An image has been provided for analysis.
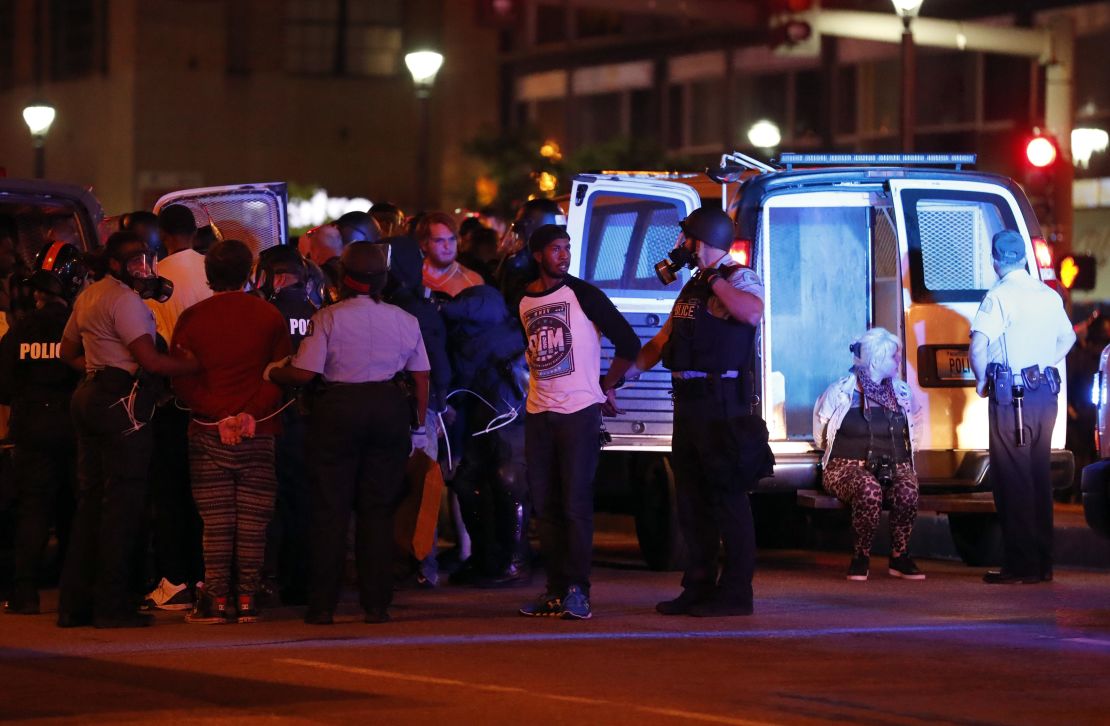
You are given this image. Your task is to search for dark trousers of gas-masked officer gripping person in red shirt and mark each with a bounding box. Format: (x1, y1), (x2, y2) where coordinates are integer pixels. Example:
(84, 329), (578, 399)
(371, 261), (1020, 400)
(58, 369), (151, 618)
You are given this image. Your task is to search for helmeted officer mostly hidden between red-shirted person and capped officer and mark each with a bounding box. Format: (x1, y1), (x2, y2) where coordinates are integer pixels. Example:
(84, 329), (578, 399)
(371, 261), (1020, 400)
(251, 244), (316, 605)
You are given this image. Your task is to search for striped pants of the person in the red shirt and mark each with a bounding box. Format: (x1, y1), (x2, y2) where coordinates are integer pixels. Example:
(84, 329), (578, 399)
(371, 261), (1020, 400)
(189, 428), (278, 597)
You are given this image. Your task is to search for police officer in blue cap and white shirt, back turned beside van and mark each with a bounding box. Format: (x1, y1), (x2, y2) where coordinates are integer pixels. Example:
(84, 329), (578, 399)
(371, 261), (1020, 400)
(970, 230), (1076, 585)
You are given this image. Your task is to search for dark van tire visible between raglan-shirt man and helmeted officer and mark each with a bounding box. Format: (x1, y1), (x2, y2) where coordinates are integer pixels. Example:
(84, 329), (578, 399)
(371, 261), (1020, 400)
(635, 456), (686, 571)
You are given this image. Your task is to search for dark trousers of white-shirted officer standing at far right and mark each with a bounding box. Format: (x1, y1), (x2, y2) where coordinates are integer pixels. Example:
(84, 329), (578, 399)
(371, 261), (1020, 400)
(988, 384), (1057, 576)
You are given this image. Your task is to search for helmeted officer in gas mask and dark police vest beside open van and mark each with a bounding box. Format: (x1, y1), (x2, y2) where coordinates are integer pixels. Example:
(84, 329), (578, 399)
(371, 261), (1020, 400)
(637, 208), (774, 616)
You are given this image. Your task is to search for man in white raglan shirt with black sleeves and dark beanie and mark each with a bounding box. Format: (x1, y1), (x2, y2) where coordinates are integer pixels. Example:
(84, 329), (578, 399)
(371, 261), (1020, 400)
(519, 224), (639, 619)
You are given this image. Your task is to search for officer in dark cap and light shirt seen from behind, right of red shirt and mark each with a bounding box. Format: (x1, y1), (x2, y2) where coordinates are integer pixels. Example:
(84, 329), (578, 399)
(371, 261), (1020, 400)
(266, 242), (430, 625)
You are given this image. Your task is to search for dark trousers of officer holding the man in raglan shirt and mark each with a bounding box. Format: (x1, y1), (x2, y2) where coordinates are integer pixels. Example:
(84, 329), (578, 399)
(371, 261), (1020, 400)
(670, 380), (765, 604)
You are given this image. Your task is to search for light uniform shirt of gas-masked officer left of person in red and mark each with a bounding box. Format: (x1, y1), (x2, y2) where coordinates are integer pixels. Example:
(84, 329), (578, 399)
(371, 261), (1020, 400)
(62, 275), (155, 375)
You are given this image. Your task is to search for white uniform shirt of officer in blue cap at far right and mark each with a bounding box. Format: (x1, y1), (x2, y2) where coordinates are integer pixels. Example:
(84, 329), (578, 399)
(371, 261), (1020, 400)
(971, 270), (1072, 374)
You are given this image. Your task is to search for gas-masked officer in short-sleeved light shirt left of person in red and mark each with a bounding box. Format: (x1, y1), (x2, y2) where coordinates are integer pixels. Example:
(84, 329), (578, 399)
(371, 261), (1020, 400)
(58, 232), (198, 627)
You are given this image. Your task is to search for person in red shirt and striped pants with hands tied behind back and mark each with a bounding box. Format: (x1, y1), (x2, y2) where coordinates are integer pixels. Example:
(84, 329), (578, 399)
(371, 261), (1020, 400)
(172, 240), (291, 624)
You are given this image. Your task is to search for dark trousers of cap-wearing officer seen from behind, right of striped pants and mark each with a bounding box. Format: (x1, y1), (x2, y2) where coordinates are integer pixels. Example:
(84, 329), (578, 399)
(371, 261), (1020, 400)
(309, 383), (411, 612)
